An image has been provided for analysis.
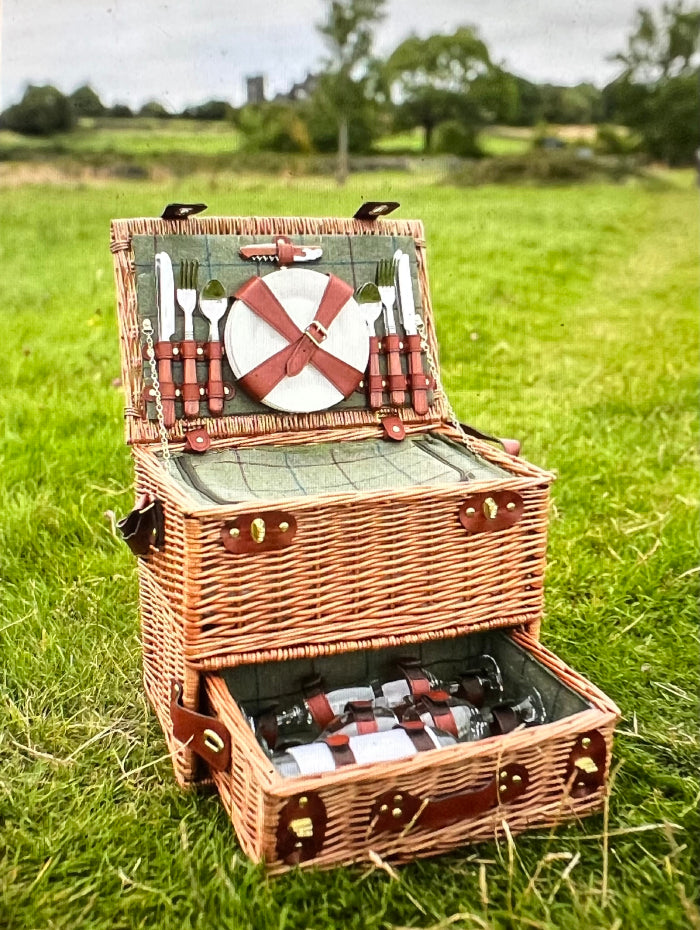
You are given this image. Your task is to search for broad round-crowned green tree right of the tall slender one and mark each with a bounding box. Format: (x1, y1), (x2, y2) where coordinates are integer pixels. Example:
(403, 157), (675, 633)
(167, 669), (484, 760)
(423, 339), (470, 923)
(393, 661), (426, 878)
(386, 26), (517, 151)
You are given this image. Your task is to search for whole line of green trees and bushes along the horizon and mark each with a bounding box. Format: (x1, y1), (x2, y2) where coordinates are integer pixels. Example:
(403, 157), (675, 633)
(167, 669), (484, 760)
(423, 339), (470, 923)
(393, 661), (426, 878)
(0, 0), (700, 167)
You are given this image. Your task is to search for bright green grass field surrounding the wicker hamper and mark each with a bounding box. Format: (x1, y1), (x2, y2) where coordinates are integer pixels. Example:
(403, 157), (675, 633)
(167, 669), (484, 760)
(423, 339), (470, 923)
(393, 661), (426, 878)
(0, 174), (700, 930)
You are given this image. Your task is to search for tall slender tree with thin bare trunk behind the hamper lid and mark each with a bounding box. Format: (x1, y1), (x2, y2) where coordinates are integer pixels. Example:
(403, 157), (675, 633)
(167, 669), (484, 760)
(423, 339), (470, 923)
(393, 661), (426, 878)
(317, 0), (386, 184)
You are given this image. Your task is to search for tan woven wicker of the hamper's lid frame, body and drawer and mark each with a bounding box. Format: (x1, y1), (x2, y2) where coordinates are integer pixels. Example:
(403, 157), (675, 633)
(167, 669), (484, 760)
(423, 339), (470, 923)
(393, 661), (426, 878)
(111, 210), (619, 871)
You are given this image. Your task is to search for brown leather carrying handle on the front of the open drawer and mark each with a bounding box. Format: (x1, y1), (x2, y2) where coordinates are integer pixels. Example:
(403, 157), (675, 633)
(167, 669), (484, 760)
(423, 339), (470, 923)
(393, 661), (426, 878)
(370, 764), (530, 833)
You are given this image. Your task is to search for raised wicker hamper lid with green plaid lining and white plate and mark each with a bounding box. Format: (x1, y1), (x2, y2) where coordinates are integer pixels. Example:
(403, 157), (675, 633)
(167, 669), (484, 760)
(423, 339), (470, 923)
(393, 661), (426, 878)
(111, 217), (447, 444)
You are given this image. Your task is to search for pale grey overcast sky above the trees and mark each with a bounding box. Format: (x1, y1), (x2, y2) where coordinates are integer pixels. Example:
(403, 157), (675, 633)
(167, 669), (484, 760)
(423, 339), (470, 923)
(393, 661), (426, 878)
(0, 0), (662, 110)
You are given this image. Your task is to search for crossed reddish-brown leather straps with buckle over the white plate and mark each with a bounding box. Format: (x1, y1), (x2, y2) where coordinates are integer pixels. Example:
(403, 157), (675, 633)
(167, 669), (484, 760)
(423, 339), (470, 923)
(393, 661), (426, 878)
(235, 275), (362, 399)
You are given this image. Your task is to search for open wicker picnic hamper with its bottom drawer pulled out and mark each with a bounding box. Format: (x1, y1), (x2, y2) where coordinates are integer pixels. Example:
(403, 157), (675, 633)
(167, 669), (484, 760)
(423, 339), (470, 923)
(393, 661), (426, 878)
(111, 201), (618, 871)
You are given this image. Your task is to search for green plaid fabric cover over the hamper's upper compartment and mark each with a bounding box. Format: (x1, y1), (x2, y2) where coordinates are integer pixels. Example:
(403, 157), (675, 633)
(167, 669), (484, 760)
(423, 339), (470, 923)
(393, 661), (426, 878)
(170, 434), (506, 504)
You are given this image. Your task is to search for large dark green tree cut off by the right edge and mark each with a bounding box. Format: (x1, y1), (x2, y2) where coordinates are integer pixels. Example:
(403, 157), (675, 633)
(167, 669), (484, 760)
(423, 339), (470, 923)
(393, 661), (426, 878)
(604, 0), (700, 165)
